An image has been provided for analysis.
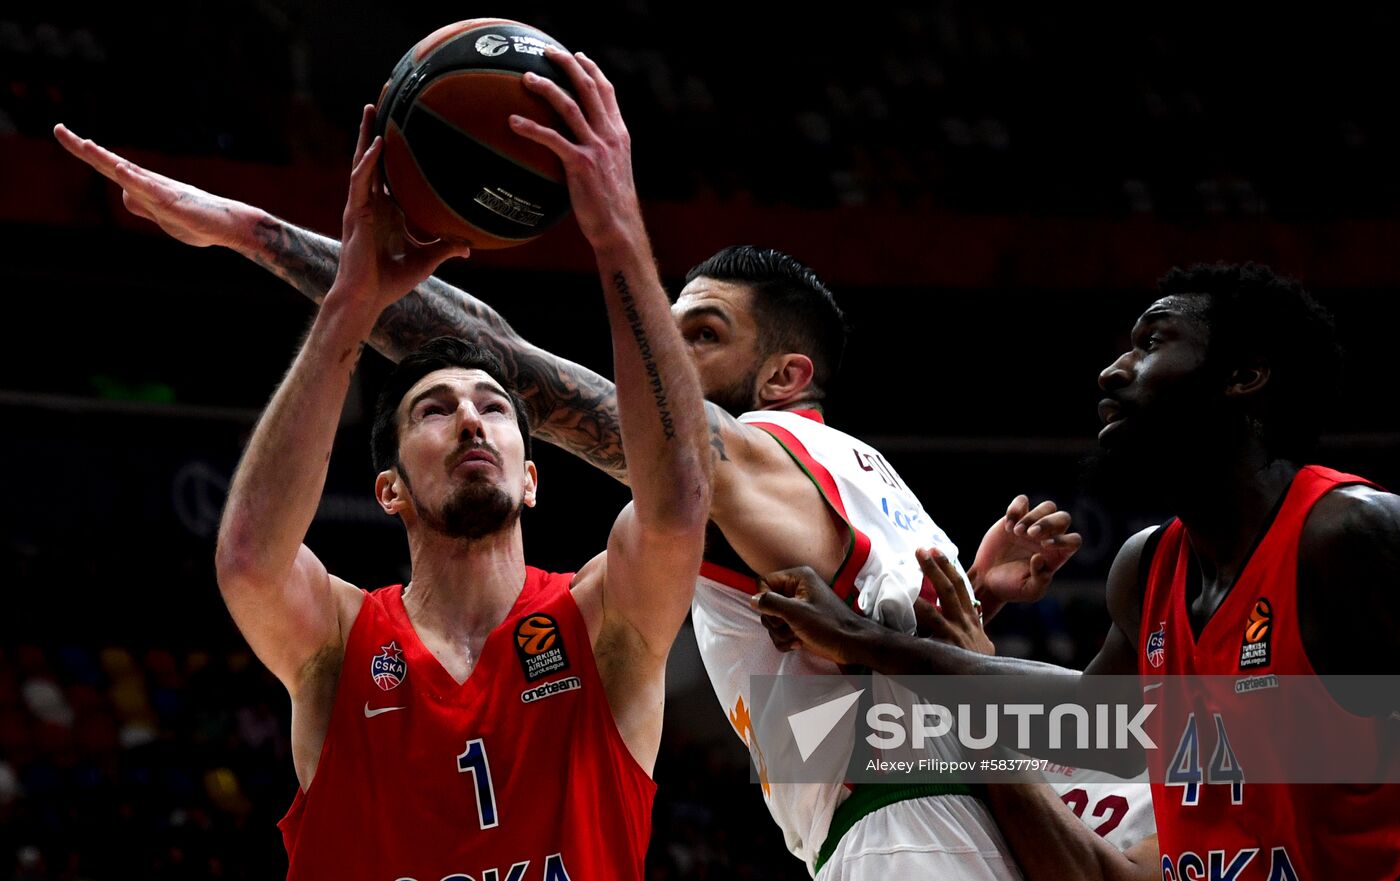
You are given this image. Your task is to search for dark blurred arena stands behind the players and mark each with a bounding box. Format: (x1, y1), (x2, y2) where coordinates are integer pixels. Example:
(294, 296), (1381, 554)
(0, 0), (1400, 881)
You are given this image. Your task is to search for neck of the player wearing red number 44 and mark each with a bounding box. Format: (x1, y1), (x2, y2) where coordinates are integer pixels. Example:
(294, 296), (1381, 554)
(1177, 451), (1298, 578)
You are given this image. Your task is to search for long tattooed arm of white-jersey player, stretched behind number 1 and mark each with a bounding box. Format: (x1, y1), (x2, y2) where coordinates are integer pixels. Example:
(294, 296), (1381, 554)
(55, 126), (789, 515)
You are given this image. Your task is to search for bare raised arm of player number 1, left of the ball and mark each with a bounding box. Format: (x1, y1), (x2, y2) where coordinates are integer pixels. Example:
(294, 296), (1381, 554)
(210, 108), (465, 686)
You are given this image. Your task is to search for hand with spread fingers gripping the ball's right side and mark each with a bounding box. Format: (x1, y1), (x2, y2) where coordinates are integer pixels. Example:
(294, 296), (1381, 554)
(510, 46), (643, 249)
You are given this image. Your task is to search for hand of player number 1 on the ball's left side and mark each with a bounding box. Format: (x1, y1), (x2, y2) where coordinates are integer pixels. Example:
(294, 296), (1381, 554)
(328, 105), (470, 314)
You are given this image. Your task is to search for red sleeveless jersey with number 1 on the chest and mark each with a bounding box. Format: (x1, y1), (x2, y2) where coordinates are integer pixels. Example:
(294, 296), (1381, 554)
(279, 567), (655, 881)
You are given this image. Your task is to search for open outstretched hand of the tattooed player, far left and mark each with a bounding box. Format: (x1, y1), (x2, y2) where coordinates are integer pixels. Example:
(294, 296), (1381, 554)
(53, 123), (252, 248)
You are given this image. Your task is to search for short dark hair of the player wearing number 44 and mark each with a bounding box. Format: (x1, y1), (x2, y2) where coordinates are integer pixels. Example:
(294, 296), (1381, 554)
(1158, 263), (1343, 458)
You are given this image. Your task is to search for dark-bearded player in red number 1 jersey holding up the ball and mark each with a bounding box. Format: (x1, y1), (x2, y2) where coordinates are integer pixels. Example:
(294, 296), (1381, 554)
(217, 52), (710, 881)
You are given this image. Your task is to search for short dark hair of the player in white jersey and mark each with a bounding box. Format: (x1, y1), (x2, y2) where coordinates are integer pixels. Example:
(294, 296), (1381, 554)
(686, 245), (847, 395)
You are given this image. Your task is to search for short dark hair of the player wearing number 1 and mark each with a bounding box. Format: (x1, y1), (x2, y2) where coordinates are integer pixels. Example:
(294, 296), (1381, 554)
(370, 336), (531, 471)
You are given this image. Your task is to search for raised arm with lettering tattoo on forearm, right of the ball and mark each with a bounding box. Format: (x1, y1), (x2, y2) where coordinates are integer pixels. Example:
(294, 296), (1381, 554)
(510, 49), (711, 769)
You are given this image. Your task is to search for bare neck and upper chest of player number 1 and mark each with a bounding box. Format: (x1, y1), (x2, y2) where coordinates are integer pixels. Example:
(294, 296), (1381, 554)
(403, 521), (525, 640)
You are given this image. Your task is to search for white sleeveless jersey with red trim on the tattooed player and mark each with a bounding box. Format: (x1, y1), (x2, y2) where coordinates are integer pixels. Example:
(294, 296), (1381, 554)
(692, 410), (1000, 870)
